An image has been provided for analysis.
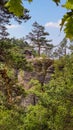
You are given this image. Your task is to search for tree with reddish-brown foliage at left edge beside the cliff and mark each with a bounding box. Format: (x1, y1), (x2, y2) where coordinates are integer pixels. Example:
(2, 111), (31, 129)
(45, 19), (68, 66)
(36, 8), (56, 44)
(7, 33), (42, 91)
(0, 64), (26, 107)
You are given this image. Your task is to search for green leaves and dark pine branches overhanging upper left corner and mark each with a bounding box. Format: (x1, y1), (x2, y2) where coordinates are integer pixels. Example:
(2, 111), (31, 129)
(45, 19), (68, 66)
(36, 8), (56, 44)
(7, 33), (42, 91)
(0, 0), (30, 39)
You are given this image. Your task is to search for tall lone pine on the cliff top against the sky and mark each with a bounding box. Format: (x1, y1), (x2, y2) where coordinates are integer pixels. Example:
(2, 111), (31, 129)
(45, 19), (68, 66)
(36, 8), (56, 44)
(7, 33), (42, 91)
(26, 22), (53, 56)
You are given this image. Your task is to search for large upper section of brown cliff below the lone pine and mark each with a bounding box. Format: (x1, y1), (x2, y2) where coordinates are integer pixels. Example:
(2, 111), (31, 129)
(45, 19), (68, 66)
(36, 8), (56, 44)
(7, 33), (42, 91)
(24, 59), (54, 85)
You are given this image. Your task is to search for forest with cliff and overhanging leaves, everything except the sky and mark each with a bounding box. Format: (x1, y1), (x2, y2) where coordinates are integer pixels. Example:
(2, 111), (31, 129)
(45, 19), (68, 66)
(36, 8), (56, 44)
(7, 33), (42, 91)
(0, 0), (73, 130)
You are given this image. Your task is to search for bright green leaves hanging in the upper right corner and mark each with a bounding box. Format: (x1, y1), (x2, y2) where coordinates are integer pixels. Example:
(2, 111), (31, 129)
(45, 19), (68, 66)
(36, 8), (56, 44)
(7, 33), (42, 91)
(53, 0), (73, 39)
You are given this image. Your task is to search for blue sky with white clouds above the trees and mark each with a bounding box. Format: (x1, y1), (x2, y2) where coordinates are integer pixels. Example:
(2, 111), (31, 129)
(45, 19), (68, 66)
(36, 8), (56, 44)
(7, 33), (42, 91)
(7, 0), (66, 45)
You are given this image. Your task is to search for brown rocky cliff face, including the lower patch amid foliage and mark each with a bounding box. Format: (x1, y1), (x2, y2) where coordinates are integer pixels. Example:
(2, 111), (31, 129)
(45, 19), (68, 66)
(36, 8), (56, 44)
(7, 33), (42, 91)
(18, 59), (54, 107)
